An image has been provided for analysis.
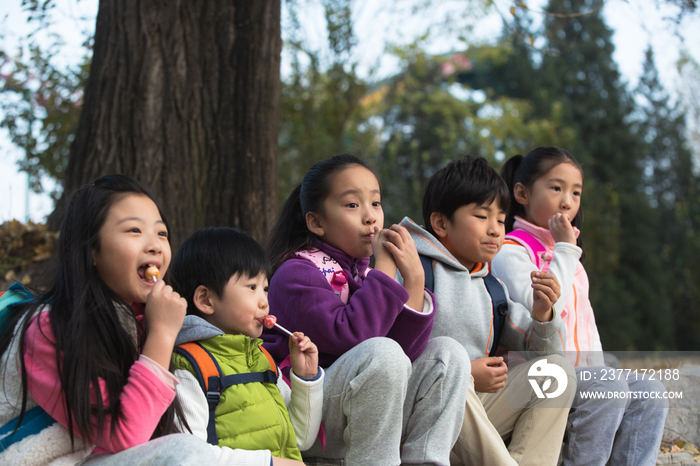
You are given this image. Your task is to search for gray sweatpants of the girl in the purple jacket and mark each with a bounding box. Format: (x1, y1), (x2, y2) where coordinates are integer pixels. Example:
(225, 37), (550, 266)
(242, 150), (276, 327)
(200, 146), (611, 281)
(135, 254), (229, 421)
(302, 337), (471, 466)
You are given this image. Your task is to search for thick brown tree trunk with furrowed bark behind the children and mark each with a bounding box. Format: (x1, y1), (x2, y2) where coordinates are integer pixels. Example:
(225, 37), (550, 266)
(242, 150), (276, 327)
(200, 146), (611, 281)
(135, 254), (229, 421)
(50, 0), (282, 248)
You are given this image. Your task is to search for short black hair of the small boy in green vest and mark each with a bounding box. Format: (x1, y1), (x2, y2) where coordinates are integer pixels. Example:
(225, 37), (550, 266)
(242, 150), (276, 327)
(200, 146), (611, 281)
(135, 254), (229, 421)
(169, 227), (270, 317)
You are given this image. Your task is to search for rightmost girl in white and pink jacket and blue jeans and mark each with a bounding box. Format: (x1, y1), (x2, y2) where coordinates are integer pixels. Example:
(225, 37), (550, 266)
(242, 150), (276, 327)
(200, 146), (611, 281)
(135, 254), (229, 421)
(491, 147), (668, 466)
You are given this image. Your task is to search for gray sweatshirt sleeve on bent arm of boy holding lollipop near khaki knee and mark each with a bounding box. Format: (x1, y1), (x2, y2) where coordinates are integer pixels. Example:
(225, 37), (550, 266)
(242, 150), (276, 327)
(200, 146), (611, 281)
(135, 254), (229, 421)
(499, 280), (566, 359)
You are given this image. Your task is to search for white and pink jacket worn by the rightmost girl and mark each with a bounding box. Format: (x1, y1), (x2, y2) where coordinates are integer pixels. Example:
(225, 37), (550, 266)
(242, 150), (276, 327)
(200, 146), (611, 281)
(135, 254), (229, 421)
(491, 217), (603, 366)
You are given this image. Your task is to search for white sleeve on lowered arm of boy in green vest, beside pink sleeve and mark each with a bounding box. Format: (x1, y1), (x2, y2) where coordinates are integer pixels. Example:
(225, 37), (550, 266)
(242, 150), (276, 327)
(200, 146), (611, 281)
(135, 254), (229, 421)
(175, 369), (272, 466)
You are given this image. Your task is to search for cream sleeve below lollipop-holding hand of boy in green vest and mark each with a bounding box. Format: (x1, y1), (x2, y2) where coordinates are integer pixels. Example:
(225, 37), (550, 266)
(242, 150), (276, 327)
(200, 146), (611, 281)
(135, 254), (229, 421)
(277, 367), (325, 451)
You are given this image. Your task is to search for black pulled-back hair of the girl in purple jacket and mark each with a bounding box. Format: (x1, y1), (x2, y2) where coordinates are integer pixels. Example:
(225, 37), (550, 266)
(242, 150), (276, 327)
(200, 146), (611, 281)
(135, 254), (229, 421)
(267, 154), (376, 273)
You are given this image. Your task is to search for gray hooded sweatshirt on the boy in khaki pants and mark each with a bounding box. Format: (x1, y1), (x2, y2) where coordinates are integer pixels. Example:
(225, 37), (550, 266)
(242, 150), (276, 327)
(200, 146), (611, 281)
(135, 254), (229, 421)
(397, 217), (566, 361)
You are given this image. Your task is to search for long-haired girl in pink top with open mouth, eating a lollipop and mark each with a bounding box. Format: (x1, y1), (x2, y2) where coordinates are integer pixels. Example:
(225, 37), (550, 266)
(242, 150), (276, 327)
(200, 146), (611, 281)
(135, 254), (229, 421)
(0, 175), (215, 465)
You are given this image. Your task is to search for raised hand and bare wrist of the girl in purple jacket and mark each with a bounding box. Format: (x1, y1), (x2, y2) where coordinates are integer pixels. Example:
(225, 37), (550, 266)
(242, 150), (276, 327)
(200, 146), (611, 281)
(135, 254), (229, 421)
(384, 224), (425, 311)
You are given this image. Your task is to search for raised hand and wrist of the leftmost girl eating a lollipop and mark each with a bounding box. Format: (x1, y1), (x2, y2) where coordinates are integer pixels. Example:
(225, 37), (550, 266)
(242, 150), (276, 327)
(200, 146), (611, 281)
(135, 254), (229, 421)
(142, 280), (187, 369)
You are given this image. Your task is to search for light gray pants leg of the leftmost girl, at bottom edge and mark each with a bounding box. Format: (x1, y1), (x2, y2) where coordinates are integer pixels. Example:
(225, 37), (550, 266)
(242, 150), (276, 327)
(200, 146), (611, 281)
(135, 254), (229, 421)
(79, 434), (217, 466)
